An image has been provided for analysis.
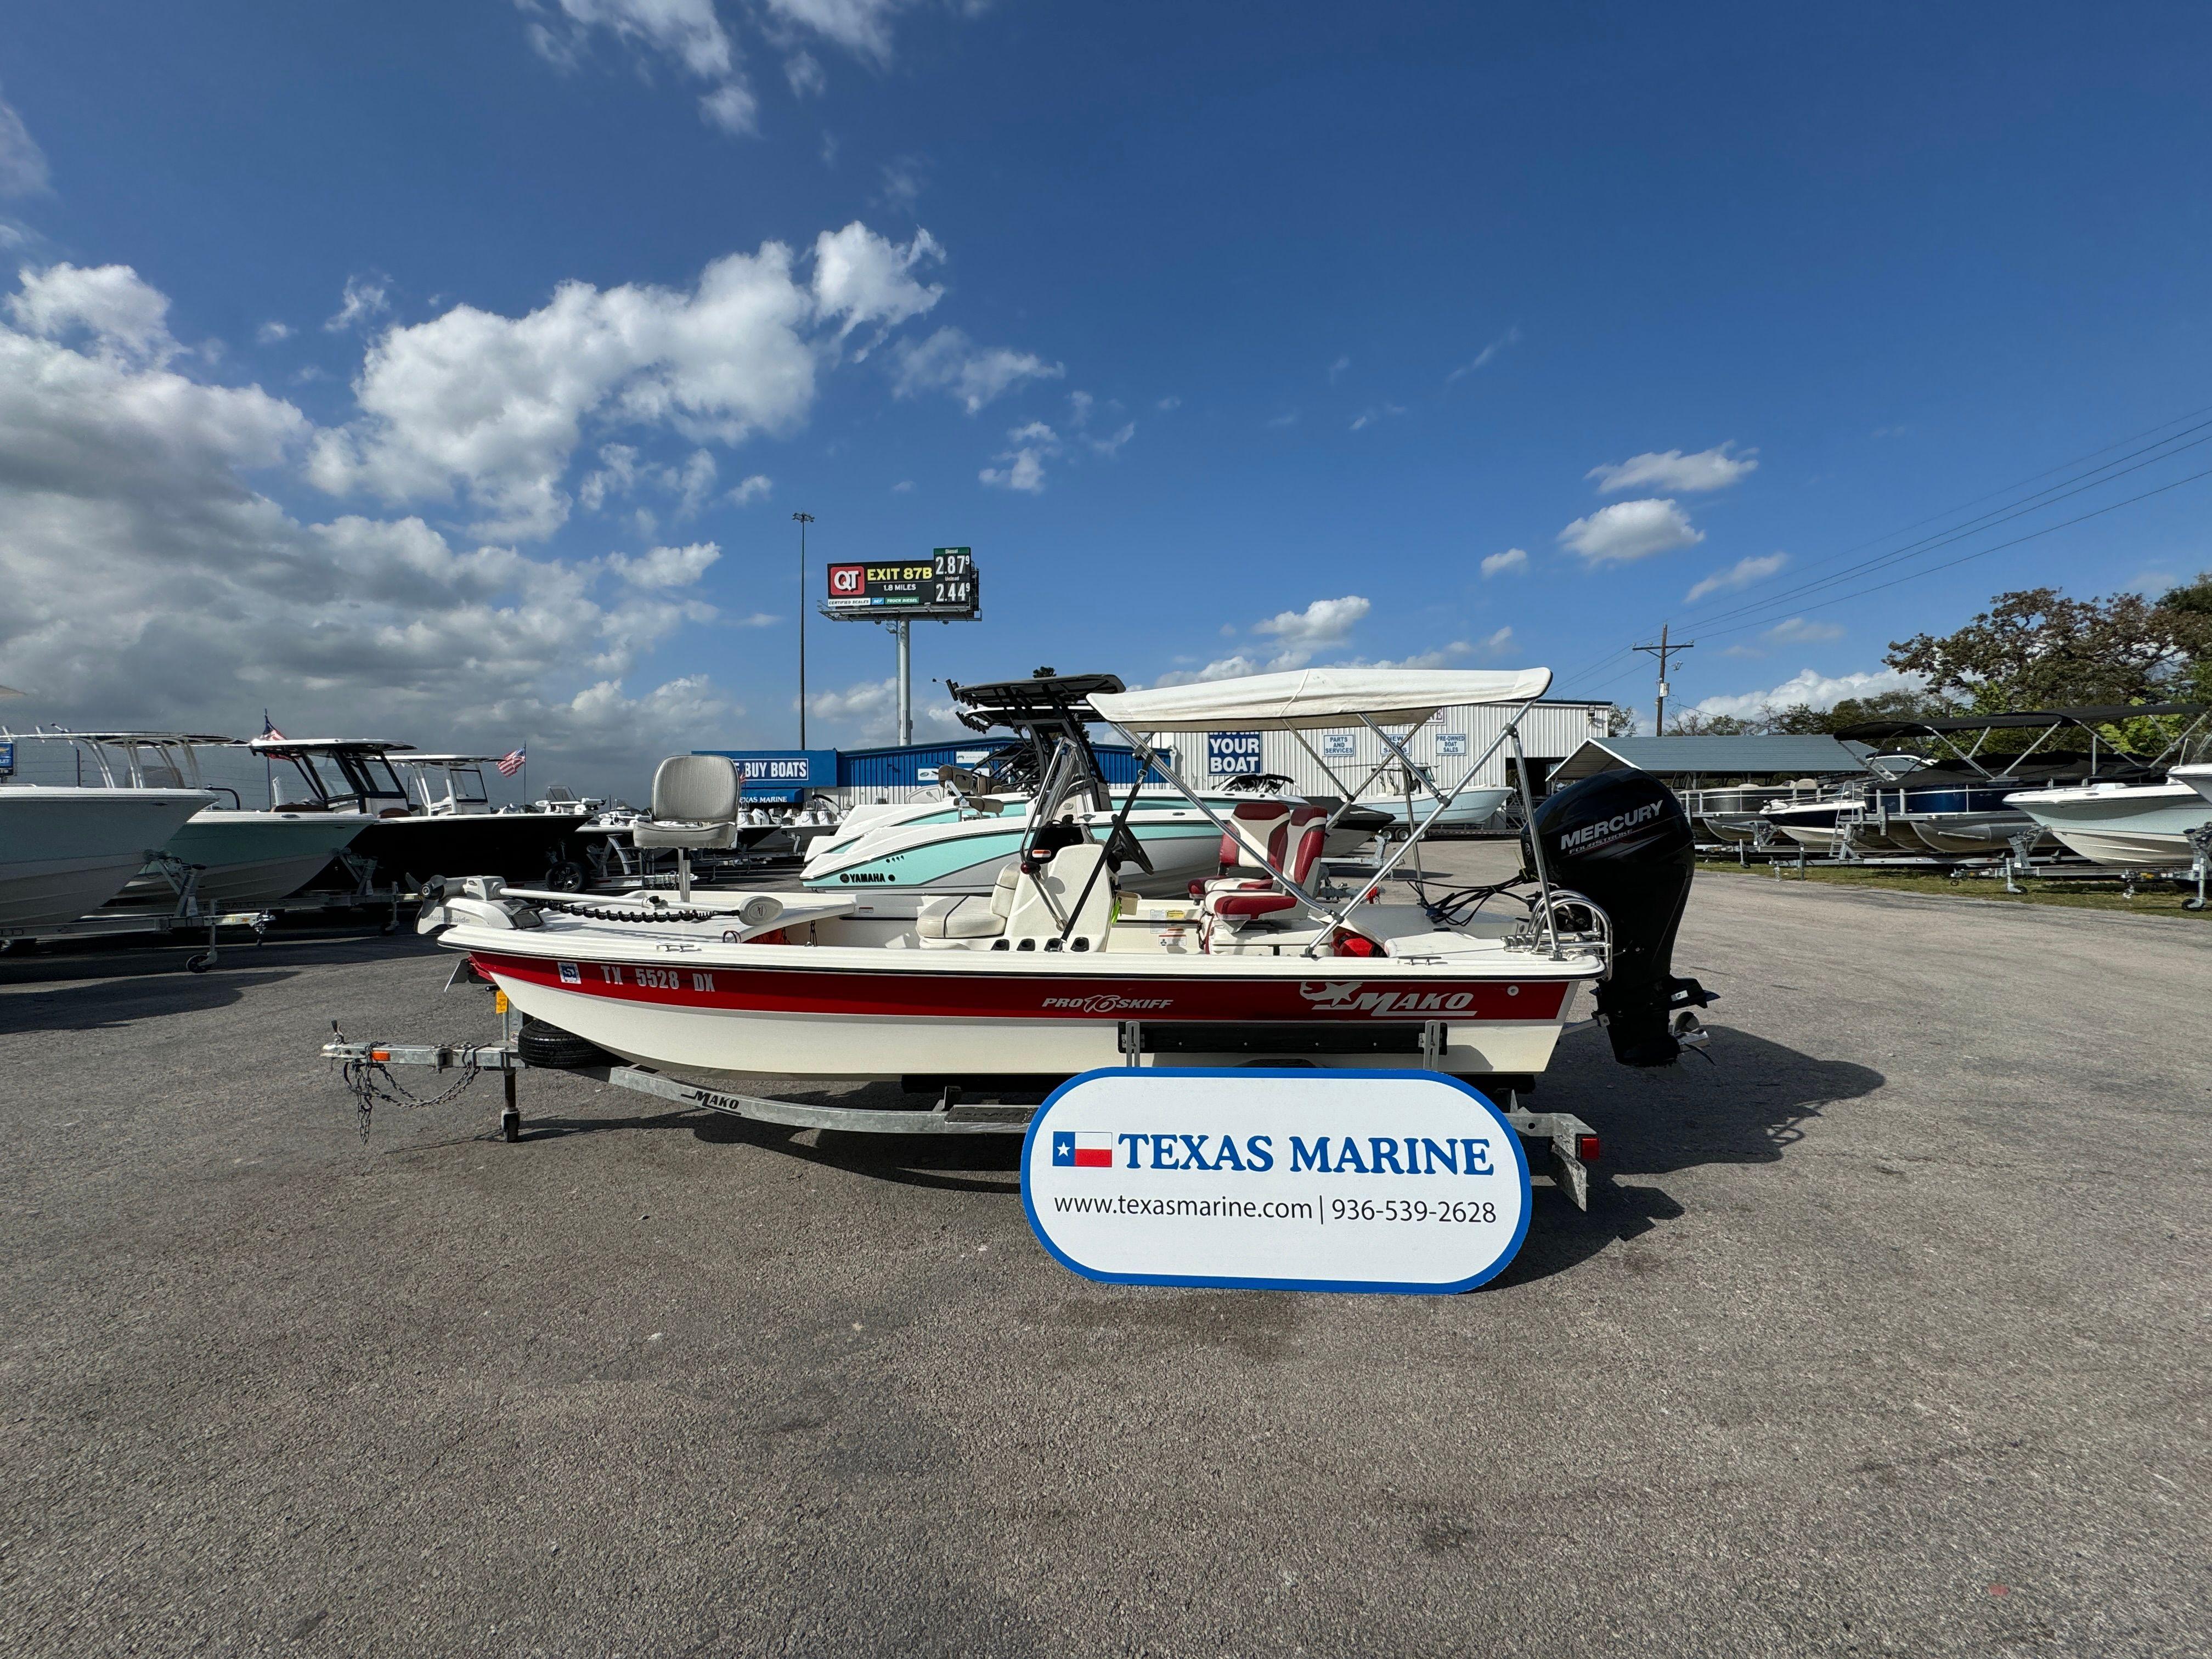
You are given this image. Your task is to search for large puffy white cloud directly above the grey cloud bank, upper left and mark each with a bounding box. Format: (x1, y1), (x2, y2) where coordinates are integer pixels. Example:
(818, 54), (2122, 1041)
(309, 241), (827, 538)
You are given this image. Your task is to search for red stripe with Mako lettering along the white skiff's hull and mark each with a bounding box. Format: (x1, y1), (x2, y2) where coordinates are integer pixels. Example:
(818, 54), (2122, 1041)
(471, 951), (1568, 1022)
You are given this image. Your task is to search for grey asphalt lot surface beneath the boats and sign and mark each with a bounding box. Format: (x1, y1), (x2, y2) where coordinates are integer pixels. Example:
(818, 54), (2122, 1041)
(0, 845), (2212, 1659)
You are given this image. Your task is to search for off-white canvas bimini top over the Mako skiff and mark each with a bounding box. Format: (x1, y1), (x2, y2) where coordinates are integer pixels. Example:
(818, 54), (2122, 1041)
(1091, 668), (1550, 732)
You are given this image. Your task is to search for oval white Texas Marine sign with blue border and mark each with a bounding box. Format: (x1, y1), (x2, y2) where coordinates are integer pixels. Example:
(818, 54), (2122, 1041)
(1022, 1068), (1528, 1294)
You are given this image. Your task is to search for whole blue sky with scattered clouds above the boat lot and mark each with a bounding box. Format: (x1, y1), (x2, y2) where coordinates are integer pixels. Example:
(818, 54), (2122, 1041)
(0, 0), (2212, 789)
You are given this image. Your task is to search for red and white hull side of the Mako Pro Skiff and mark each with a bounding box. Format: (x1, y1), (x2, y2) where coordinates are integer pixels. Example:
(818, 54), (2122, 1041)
(467, 940), (1575, 1080)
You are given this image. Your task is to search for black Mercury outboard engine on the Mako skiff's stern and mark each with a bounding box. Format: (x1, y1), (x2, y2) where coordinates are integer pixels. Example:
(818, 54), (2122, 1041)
(1522, 772), (1712, 1066)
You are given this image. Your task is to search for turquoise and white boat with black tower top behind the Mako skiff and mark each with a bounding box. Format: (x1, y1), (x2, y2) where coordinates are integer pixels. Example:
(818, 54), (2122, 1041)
(801, 673), (1398, 898)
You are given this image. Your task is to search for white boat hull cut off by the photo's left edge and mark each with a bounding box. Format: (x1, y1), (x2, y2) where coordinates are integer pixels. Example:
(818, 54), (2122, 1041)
(0, 783), (215, 934)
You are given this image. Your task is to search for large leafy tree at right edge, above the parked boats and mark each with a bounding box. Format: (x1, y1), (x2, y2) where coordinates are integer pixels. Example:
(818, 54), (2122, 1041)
(1887, 577), (2212, 714)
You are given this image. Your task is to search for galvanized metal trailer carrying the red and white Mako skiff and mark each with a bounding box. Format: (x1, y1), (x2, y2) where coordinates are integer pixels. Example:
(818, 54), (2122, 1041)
(323, 986), (1599, 1210)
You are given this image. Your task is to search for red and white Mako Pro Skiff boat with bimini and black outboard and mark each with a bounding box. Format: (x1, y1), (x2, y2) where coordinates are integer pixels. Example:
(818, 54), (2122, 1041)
(422, 668), (1708, 1093)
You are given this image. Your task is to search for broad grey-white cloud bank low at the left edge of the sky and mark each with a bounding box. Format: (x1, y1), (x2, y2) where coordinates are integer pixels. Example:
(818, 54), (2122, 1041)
(0, 270), (741, 789)
